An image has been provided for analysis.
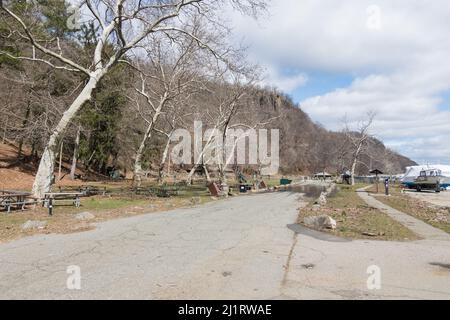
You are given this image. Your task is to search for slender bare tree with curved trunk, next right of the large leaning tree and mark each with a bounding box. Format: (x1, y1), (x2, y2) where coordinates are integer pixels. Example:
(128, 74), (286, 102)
(133, 32), (207, 186)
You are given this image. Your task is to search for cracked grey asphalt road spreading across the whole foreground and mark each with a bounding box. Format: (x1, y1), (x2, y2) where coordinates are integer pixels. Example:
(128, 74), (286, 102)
(0, 193), (450, 299)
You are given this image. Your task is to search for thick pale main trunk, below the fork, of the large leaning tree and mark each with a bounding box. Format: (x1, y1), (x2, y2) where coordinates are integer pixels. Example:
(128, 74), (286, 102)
(33, 69), (103, 199)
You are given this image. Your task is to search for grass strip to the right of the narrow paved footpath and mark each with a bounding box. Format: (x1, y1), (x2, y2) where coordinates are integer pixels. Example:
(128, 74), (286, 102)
(376, 187), (450, 233)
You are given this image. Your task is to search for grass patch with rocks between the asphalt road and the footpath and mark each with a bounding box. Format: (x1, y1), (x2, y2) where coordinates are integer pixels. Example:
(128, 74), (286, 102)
(299, 185), (417, 241)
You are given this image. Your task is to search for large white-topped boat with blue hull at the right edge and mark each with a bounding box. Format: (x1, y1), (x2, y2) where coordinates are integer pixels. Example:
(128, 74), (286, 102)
(401, 165), (450, 190)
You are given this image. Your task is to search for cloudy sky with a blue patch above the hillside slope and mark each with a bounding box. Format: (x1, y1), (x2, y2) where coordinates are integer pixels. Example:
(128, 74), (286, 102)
(232, 0), (450, 164)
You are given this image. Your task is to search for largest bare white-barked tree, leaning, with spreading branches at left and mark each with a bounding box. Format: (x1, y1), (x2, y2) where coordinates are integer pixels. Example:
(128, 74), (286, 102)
(0, 0), (265, 198)
